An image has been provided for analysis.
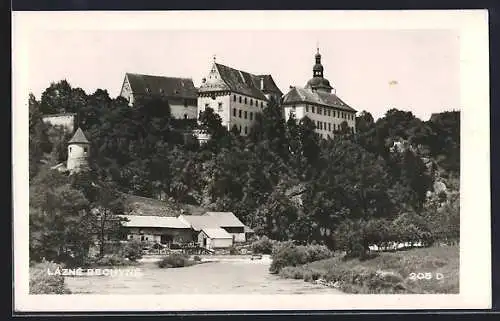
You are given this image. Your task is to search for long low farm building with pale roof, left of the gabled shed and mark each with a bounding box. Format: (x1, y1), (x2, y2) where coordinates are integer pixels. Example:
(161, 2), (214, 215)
(123, 215), (193, 244)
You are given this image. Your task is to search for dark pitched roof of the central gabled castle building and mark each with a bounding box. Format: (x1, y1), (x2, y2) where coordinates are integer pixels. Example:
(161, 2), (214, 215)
(199, 63), (282, 100)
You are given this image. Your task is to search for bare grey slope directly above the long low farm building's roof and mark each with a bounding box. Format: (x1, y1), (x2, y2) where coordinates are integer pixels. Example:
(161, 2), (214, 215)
(123, 194), (205, 217)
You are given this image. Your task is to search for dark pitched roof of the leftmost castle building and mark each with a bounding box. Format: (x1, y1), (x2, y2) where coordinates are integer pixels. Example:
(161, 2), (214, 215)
(125, 73), (198, 99)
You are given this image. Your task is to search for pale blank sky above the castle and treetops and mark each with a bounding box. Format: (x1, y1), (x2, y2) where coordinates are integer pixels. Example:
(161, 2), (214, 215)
(16, 17), (461, 120)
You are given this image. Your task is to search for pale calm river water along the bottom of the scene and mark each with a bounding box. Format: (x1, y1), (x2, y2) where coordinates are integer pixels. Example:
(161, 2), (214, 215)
(66, 259), (341, 294)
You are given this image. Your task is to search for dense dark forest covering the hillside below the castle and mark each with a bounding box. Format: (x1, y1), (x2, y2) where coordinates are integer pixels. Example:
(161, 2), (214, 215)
(29, 81), (460, 262)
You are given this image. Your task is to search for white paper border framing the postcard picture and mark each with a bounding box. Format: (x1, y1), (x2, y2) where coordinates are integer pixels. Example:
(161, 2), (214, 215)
(12, 10), (491, 312)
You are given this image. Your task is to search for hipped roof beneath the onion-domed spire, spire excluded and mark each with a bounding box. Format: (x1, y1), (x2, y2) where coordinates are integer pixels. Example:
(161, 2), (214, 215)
(283, 87), (356, 112)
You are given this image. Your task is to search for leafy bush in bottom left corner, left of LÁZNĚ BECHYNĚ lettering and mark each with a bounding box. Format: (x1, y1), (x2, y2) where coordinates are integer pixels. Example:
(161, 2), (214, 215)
(29, 262), (71, 294)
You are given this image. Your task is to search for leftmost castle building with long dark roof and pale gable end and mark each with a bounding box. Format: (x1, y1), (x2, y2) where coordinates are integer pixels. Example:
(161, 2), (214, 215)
(120, 73), (198, 119)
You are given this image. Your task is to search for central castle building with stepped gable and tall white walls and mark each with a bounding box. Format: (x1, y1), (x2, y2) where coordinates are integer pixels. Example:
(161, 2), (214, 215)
(198, 59), (283, 135)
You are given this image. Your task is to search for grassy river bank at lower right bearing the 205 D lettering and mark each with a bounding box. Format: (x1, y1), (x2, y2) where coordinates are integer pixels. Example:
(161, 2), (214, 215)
(279, 246), (459, 294)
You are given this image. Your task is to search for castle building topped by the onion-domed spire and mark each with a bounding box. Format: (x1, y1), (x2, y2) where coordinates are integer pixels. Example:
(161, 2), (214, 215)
(282, 49), (356, 138)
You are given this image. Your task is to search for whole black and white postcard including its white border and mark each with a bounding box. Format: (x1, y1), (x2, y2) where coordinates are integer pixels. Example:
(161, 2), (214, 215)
(13, 10), (491, 311)
